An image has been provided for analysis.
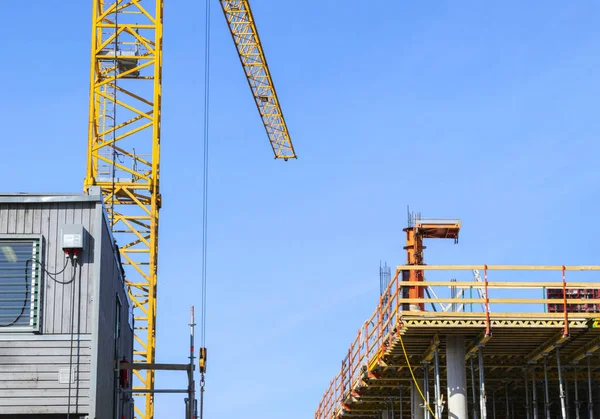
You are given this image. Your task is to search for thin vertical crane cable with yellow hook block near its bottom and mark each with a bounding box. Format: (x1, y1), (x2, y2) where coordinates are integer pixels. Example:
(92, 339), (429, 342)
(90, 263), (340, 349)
(199, 0), (211, 419)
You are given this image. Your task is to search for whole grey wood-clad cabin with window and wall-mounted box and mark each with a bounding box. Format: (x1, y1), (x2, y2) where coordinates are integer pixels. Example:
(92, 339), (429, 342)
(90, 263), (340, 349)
(0, 190), (133, 419)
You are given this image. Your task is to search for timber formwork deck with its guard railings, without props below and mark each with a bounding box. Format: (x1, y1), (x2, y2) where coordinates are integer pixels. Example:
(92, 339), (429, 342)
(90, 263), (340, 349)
(315, 265), (600, 419)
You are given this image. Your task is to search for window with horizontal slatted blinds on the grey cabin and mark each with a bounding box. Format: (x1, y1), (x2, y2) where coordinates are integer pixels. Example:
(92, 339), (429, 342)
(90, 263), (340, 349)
(0, 237), (41, 332)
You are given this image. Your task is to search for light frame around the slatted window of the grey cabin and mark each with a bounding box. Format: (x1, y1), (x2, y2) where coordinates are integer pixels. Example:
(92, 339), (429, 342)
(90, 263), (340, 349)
(0, 234), (45, 336)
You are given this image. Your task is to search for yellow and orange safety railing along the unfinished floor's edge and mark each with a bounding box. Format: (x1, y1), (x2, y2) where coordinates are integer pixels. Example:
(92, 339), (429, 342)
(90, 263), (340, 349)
(315, 265), (600, 419)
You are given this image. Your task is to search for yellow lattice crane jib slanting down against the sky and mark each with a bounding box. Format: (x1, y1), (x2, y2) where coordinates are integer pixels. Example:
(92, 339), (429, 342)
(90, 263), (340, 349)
(220, 0), (296, 160)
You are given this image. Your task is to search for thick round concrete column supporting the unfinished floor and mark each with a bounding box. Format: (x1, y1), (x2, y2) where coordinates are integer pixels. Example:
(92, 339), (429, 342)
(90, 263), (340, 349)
(446, 336), (468, 419)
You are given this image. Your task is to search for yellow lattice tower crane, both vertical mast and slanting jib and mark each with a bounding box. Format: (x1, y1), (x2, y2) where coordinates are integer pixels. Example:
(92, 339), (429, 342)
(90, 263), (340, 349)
(84, 0), (296, 419)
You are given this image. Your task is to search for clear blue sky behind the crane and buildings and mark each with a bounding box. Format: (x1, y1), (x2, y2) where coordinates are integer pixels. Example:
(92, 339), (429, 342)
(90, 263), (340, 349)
(0, 0), (600, 419)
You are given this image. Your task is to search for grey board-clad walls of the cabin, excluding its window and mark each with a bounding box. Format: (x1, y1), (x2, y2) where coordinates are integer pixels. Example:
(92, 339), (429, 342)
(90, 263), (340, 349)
(0, 197), (133, 419)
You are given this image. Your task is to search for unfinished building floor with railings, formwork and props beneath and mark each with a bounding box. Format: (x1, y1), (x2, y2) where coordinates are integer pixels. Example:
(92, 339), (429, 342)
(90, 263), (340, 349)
(315, 265), (600, 419)
